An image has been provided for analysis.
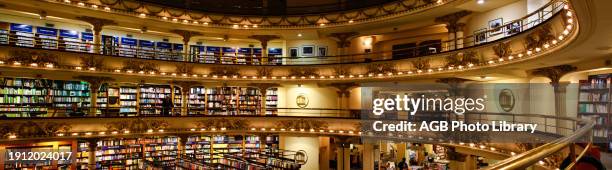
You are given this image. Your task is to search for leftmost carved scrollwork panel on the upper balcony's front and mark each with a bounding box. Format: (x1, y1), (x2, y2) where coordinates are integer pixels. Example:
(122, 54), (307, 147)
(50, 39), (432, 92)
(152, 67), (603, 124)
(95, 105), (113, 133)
(7, 50), (57, 64)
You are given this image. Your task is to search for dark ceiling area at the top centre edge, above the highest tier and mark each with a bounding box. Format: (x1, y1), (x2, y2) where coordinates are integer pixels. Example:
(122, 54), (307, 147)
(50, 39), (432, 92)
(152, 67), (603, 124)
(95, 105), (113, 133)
(135, 0), (397, 16)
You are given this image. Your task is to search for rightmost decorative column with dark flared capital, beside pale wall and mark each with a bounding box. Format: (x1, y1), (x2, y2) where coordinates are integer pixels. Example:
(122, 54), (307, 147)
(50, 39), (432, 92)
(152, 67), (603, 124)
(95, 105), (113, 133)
(532, 65), (576, 133)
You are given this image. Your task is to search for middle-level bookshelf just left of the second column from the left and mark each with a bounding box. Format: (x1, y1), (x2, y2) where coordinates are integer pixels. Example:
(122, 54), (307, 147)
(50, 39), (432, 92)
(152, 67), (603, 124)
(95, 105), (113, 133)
(138, 85), (172, 115)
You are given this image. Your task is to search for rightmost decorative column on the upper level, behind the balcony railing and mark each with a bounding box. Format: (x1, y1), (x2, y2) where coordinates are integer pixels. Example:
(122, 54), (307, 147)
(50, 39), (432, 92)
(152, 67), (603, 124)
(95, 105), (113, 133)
(435, 11), (472, 51)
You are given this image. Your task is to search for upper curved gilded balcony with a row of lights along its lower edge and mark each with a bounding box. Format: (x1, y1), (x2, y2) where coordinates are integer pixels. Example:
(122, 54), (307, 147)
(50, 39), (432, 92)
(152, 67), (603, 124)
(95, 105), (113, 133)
(0, 0), (578, 81)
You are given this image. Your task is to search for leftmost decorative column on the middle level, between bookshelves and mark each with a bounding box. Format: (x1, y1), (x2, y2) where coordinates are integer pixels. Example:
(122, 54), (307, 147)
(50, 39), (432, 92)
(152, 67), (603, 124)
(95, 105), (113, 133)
(74, 76), (115, 116)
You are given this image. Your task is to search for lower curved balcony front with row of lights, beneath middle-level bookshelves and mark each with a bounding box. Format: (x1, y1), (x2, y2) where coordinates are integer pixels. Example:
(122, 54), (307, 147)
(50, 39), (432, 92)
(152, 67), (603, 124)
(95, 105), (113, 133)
(0, 113), (595, 169)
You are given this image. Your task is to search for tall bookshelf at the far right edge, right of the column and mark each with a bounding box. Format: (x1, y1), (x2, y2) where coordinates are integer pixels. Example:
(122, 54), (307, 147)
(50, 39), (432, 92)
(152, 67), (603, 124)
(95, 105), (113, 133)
(578, 74), (612, 151)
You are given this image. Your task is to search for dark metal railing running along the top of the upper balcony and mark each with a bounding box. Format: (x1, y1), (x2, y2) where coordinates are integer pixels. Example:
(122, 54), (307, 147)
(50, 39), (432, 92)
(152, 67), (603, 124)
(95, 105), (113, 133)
(0, 0), (568, 65)
